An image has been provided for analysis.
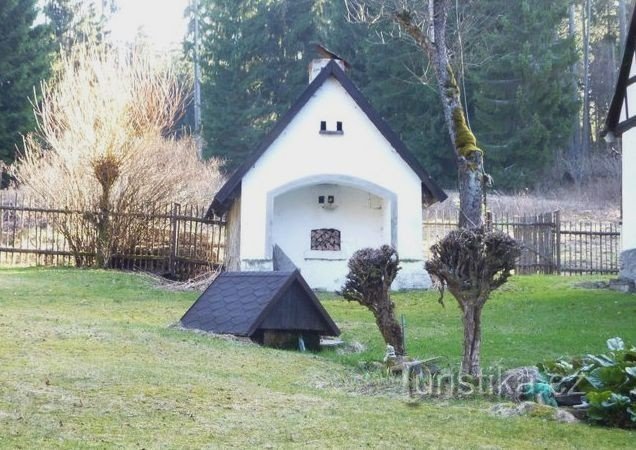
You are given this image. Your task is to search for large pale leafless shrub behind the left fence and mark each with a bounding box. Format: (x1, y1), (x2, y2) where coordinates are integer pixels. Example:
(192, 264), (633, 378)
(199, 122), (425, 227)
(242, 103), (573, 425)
(12, 43), (222, 266)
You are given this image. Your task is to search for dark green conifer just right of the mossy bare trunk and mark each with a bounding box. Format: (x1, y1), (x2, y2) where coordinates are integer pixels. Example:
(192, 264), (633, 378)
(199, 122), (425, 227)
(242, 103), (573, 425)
(469, 0), (577, 188)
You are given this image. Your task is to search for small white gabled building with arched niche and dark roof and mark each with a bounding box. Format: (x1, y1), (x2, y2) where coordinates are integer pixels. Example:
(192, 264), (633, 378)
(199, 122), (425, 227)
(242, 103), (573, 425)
(208, 58), (446, 291)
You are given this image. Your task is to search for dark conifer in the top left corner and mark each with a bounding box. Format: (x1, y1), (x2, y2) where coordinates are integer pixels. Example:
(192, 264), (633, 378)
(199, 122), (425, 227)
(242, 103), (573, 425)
(0, 0), (51, 167)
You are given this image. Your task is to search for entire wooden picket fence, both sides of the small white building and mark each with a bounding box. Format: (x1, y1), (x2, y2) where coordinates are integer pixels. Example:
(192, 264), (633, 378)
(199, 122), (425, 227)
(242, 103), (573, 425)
(0, 194), (620, 279)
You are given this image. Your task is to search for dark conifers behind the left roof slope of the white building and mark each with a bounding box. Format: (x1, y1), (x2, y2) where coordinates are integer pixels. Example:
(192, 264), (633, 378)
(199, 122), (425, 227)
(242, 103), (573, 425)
(199, 0), (342, 170)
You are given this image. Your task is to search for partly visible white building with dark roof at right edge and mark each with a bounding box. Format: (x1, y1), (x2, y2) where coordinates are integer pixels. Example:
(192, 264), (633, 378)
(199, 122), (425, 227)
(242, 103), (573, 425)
(602, 5), (636, 282)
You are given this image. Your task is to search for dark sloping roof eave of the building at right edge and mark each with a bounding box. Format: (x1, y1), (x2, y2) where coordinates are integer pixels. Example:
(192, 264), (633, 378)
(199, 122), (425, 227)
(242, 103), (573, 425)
(601, 8), (636, 136)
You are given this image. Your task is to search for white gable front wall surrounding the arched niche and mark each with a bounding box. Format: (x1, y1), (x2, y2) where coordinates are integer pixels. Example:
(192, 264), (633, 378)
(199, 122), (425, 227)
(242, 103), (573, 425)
(241, 78), (423, 287)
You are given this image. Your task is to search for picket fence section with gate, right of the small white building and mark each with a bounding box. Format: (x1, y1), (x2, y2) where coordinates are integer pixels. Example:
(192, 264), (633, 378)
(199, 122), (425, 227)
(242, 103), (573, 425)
(423, 211), (620, 274)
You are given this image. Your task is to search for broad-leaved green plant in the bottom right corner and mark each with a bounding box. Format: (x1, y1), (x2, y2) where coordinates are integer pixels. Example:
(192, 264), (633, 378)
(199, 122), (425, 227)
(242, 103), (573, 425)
(539, 337), (636, 428)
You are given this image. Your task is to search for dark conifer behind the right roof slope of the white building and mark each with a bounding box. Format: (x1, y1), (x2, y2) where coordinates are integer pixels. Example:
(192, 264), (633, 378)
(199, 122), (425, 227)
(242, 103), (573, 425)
(321, 0), (456, 185)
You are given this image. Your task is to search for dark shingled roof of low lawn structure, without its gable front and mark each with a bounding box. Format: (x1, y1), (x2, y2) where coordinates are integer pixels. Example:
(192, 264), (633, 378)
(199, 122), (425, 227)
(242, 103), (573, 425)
(181, 270), (340, 336)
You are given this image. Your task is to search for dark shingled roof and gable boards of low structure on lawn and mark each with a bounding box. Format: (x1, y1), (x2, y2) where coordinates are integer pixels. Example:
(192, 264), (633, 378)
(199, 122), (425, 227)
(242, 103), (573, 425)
(181, 270), (340, 336)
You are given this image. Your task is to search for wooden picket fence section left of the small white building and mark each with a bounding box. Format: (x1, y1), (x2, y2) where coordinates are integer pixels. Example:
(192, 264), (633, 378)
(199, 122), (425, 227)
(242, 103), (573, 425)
(0, 196), (225, 279)
